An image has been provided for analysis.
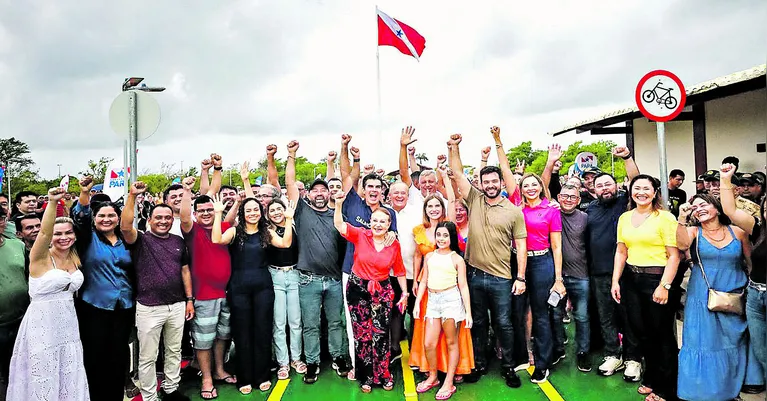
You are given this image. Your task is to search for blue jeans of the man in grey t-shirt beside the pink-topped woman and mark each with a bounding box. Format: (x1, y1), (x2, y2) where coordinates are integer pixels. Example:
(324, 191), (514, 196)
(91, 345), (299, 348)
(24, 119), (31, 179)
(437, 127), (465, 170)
(553, 276), (591, 354)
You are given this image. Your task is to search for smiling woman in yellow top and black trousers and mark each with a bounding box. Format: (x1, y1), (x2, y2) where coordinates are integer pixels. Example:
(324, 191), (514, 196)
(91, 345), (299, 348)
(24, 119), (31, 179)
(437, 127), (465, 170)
(612, 174), (680, 401)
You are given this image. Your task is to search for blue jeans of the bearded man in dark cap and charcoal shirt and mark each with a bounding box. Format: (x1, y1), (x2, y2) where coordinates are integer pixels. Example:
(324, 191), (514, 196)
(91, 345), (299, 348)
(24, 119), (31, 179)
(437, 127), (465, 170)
(298, 271), (347, 364)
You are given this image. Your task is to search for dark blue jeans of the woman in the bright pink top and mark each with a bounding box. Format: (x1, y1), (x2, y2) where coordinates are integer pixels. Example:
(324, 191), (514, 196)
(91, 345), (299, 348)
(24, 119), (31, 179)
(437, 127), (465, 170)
(526, 252), (562, 370)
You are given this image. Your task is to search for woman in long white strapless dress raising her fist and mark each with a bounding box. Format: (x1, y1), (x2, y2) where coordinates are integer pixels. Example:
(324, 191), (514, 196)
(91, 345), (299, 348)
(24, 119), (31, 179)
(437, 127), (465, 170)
(7, 188), (90, 401)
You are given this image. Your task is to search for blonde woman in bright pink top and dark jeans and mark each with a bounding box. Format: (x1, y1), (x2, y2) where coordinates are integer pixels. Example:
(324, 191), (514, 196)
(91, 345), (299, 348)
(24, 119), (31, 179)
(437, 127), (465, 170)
(515, 174), (565, 383)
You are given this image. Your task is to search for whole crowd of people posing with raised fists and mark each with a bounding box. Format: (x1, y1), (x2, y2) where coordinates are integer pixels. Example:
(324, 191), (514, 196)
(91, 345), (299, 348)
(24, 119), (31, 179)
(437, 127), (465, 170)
(0, 127), (767, 401)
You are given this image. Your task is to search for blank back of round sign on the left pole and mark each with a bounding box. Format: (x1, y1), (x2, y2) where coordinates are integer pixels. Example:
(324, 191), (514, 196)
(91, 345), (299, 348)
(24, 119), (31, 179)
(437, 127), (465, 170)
(109, 91), (160, 141)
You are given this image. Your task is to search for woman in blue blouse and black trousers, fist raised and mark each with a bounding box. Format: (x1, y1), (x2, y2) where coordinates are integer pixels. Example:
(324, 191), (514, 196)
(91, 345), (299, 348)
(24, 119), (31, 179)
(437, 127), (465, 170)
(72, 177), (135, 401)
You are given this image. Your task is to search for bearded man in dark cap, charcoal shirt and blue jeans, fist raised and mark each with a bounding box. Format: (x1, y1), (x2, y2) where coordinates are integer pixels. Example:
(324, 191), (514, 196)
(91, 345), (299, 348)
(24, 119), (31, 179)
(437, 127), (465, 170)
(285, 141), (352, 384)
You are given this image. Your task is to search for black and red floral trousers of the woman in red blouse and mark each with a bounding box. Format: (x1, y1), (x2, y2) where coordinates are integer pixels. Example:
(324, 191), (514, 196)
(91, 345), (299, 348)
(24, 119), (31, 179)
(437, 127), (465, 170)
(346, 274), (394, 386)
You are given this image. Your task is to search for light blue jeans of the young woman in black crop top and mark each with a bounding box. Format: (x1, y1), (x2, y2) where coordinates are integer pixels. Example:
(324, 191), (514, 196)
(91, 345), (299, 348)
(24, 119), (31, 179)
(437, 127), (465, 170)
(269, 268), (303, 366)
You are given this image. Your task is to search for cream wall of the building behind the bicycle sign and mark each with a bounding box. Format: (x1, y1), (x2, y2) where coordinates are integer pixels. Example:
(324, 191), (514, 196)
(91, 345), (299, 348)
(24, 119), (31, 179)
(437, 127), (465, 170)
(634, 89), (767, 194)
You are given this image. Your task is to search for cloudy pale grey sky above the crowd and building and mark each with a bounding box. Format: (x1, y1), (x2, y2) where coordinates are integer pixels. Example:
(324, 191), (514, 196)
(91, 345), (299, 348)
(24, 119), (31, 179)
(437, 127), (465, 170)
(0, 0), (767, 177)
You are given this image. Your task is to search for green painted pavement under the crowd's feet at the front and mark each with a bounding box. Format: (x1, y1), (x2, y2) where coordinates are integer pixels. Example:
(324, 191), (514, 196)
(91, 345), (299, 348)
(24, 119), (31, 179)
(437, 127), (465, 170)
(172, 323), (644, 401)
